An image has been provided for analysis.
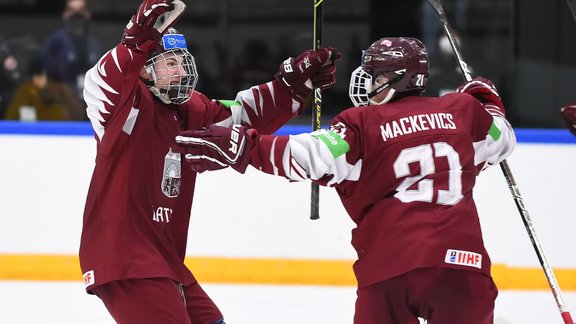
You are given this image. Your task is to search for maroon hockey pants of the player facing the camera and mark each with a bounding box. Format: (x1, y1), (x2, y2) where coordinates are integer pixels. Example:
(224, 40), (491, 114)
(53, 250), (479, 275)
(94, 278), (223, 324)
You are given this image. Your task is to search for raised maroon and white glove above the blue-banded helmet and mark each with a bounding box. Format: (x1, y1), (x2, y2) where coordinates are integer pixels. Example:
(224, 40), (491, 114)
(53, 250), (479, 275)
(122, 0), (186, 46)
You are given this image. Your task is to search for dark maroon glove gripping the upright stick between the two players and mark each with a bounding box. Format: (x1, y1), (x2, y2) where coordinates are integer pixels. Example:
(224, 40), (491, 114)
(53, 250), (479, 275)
(275, 47), (342, 102)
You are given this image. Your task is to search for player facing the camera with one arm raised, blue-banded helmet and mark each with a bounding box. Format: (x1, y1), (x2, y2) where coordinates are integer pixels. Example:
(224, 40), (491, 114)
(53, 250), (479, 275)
(80, 0), (338, 324)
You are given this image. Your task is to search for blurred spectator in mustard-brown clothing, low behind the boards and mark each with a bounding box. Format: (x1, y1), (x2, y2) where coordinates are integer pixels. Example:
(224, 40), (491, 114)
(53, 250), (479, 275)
(6, 56), (83, 121)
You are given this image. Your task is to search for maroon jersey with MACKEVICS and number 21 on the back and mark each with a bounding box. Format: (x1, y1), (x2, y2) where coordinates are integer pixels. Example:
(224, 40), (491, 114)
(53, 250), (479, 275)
(252, 93), (516, 287)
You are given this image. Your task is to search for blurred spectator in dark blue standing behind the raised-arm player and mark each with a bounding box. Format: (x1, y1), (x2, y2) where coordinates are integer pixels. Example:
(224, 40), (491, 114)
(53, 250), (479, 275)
(45, 0), (102, 99)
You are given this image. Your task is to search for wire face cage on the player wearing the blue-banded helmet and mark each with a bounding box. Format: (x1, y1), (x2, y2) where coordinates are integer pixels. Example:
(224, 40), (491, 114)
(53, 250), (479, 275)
(146, 49), (198, 104)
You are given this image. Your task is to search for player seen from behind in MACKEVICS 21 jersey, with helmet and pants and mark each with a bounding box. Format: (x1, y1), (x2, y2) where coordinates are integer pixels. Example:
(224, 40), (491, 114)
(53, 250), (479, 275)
(177, 37), (516, 324)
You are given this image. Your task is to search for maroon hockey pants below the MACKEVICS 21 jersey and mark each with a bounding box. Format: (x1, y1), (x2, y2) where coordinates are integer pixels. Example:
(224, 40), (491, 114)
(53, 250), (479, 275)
(354, 268), (498, 324)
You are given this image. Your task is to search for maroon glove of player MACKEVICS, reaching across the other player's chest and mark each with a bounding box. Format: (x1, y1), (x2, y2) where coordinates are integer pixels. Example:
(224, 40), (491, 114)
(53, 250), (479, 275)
(176, 125), (256, 173)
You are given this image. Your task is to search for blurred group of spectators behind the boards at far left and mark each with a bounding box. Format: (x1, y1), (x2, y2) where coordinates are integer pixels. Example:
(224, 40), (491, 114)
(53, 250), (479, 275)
(0, 0), (103, 121)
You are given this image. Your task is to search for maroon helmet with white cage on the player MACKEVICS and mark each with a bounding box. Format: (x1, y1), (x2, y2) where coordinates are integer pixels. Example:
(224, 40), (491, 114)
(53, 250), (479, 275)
(350, 37), (428, 106)
